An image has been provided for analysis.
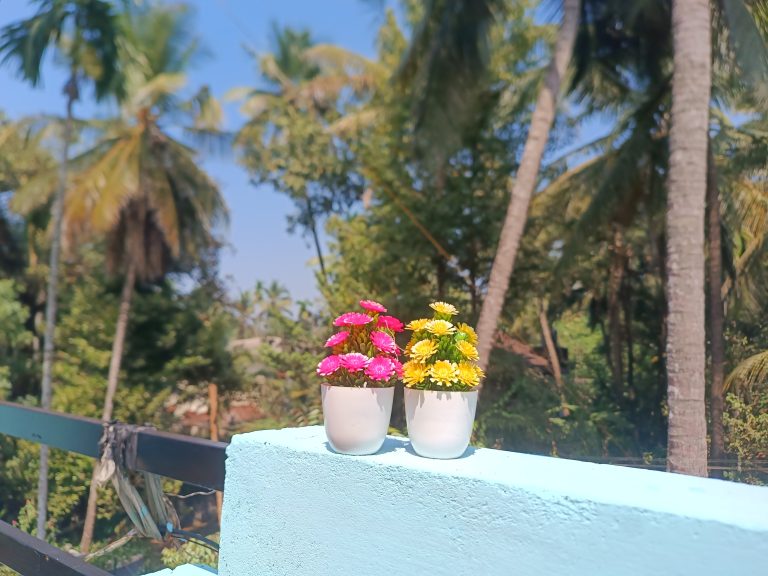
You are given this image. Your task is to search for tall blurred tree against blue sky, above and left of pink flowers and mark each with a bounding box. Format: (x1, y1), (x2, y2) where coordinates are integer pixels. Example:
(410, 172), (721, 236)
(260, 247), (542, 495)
(230, 26), (378, 279)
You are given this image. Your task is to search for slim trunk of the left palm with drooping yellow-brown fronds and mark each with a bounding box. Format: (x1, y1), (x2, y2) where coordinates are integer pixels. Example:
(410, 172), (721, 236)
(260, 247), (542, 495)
(80, 262), (136, 554)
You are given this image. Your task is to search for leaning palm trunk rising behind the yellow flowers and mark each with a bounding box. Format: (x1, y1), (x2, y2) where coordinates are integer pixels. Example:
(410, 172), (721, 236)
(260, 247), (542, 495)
(477, 0), (581, 370)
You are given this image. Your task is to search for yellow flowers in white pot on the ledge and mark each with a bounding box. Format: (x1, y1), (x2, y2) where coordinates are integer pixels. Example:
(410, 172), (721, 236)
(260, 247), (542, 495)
(403, 302), (484, 458)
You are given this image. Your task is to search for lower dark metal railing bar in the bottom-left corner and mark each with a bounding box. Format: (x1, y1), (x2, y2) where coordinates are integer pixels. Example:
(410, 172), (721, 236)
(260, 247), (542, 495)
(0, 520), (109, 576)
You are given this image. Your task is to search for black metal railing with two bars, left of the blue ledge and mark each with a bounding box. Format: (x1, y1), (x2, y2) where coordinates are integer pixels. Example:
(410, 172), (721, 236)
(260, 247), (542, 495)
(0, 402), (227, 576)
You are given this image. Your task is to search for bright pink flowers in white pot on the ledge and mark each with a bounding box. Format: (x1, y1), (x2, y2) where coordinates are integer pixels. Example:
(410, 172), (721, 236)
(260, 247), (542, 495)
(317, 300), (403, 455)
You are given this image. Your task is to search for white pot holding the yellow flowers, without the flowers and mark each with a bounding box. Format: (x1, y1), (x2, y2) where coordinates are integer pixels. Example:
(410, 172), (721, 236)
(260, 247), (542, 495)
(405, 388), (477, 459)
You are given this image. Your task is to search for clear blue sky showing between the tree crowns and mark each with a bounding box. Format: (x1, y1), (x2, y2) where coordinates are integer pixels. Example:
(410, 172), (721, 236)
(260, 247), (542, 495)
(0, 0), (383, 299)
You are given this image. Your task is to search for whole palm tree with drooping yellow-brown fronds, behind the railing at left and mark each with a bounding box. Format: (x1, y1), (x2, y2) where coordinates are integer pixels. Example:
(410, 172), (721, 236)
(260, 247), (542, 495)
(48, 7), (226, 552)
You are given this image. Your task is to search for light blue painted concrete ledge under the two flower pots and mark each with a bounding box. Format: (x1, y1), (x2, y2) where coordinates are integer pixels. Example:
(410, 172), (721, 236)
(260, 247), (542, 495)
(219, 427), (768, 576)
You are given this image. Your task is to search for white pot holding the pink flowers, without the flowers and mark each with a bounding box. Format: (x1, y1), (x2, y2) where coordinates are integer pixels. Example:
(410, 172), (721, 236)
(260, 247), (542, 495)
(320, 384), (395, 456)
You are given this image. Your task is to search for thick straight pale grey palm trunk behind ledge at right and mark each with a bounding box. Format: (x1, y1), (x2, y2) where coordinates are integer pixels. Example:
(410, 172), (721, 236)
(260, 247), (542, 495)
(667, 0), (711, 476)
